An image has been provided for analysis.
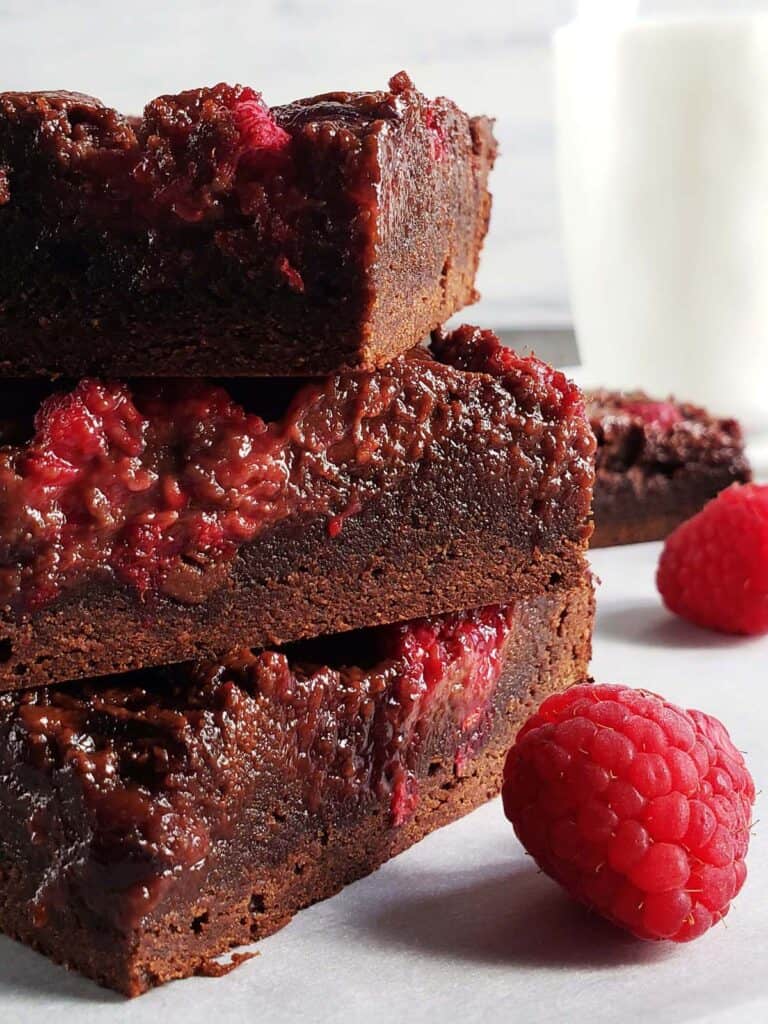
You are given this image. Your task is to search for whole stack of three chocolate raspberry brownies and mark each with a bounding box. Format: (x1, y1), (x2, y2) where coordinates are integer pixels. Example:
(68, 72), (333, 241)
(0, 73), (595, 994)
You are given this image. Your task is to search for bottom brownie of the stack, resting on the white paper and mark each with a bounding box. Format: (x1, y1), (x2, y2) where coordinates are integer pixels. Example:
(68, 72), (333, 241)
(0, 574), (593, 995)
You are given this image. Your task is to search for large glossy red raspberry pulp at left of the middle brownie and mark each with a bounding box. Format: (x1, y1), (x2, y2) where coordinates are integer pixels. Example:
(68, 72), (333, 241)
(0, 381), (287, 607)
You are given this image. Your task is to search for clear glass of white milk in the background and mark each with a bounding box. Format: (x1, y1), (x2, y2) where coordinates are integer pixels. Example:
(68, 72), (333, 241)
(554, 0), (768, 431)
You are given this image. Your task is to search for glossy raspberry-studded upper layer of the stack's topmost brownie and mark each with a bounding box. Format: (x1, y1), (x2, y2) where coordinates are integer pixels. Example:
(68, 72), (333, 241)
(0, 72), (466, 232)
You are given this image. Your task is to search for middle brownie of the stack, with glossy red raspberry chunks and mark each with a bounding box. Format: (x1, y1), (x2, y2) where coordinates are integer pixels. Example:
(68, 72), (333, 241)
(0, 327), (595, 690)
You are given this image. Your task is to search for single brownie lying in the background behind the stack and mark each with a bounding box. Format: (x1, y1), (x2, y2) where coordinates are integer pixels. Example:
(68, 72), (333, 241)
(587, 390), (752, 548)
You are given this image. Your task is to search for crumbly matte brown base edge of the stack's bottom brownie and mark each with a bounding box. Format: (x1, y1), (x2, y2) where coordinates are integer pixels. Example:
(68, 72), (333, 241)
(0, 577), (594, 995)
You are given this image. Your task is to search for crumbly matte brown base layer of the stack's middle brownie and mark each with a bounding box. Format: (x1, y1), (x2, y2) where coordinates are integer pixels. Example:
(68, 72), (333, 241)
(0, 527), (585, 692)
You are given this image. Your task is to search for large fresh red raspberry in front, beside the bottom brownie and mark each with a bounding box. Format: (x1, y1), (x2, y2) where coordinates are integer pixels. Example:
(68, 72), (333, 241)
(503, 684), (755, 942)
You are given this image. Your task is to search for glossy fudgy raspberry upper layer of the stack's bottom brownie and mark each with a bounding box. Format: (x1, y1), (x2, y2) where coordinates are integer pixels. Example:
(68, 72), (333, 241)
(0, 606), (514, 931)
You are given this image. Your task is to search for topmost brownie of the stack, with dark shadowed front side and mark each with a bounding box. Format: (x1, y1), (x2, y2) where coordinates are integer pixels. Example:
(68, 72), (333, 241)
(0, 73), (496, 377)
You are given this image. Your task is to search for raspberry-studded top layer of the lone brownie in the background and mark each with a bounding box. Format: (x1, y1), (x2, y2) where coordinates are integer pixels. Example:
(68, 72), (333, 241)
(586, 390), (749, 478)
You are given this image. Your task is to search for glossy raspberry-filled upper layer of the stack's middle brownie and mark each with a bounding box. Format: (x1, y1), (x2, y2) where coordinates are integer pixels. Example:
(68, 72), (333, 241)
(0, 327), (595, 614)
